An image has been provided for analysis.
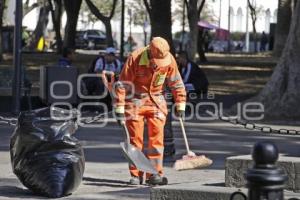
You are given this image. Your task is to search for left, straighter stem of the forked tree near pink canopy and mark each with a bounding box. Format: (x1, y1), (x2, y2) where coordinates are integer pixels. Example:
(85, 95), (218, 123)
(187, 0), (198, 60)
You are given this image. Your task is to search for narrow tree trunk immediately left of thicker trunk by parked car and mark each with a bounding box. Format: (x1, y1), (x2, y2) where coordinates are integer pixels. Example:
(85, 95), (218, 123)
(49, 0), (63, 54)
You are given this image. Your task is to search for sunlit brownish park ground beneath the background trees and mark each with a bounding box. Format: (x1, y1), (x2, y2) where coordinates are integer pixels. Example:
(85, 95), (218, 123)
(0, 51), (278, 95)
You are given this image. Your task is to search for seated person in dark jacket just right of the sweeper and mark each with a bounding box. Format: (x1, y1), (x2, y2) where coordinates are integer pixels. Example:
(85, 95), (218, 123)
(176, 51), (209, 94)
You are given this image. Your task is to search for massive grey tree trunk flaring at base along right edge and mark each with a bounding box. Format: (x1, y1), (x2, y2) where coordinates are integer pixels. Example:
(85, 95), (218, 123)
(257, 1), (300, 119)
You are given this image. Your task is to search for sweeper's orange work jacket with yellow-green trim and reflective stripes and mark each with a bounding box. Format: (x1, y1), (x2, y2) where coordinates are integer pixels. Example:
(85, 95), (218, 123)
(114, 47), (186, 115)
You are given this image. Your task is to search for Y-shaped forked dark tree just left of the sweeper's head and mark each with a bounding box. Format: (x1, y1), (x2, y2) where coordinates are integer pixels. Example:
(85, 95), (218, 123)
(86, 0), (118, 46)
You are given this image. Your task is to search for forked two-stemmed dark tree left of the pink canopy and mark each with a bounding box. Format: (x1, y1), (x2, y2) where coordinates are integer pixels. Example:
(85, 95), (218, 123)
(185, 0), (206, 61)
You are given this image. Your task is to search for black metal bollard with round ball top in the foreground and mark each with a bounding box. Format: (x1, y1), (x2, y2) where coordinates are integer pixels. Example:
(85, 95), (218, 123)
(245, 142), (287, 200)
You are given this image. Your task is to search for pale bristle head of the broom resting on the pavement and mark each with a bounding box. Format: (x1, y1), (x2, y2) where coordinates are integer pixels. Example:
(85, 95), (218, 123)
(174, 155), (213, 171)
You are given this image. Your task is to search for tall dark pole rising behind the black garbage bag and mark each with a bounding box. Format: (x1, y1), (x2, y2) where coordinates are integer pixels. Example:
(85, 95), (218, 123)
(12, 0), (23, 114)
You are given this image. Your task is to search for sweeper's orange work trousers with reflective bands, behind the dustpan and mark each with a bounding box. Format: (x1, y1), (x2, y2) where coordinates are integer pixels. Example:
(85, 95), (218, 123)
(126, 104), (166, 178)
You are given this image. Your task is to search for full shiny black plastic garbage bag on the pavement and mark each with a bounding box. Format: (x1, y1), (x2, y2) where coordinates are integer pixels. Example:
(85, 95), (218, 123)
(10, 108), (85, 198)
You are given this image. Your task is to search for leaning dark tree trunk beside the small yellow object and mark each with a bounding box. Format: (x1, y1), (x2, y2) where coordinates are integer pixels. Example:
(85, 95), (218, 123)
(30, 5), (50, 49)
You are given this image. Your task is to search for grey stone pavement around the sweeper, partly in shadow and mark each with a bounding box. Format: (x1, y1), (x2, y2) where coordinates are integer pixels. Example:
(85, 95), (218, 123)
(0, 119), (300, 200)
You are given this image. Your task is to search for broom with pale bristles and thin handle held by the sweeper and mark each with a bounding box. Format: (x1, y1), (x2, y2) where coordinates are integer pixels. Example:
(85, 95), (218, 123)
(174, 117), (213, 171)
